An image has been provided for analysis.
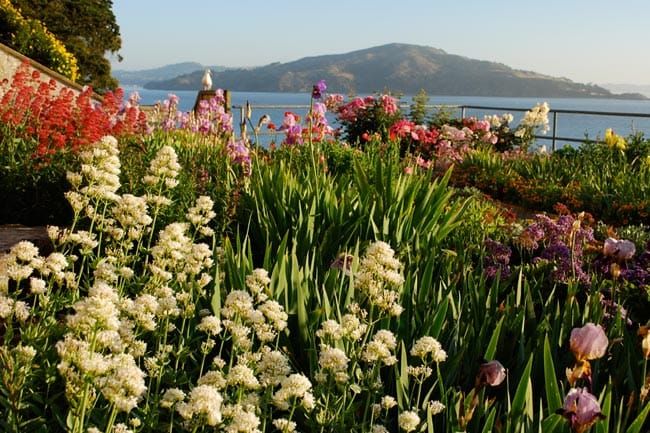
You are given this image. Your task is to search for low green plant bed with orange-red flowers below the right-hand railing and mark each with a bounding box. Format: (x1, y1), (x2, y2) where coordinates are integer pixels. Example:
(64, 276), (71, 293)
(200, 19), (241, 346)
(452, 136), (650, 225)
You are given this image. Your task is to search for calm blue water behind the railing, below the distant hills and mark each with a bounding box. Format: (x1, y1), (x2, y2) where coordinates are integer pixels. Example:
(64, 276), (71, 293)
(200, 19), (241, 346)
(126, 89), (650, 147)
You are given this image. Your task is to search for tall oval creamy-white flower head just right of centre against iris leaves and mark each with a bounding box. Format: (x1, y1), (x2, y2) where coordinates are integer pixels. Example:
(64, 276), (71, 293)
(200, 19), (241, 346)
(354, 241), (404, 316)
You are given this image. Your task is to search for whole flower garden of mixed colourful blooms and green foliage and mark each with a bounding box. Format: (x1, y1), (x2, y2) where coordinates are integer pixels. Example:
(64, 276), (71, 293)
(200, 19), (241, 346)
(0, 67), (650, 433)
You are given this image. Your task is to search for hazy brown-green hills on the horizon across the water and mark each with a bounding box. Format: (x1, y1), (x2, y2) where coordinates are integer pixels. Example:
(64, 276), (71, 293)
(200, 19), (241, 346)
(144, 44), (644, 99)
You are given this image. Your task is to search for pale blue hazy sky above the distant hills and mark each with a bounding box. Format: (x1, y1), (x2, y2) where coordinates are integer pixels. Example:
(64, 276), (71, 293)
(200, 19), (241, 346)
(113, 0), (650, 84)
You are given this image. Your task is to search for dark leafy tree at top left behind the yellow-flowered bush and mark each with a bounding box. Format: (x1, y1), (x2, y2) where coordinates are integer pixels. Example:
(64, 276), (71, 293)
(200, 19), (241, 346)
(11, 0), (122, 91)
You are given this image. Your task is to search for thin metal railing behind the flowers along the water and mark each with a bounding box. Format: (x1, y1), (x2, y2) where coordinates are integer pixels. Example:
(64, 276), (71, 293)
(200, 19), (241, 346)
(232, 103), (650, 151)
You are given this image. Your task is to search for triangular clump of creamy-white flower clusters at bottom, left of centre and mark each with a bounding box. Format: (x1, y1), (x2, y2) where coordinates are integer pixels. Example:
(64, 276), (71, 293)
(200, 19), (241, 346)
(161, 269), (308, 433)
